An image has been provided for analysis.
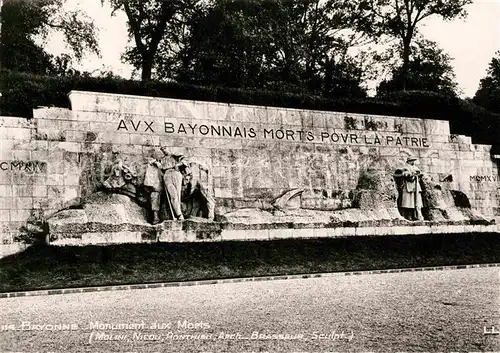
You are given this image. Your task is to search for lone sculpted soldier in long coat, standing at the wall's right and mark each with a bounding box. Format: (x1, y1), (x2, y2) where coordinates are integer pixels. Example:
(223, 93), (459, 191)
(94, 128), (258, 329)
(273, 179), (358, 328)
(398, 158), (423, 221)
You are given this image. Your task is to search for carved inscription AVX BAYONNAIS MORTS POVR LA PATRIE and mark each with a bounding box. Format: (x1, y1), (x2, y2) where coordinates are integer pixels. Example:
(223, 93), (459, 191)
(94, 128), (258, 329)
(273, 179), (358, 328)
(117, 119), (430, 148)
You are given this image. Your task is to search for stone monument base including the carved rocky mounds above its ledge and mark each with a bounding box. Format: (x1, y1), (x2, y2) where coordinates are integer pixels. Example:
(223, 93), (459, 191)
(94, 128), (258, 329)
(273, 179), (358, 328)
(48, 192), (498, 245)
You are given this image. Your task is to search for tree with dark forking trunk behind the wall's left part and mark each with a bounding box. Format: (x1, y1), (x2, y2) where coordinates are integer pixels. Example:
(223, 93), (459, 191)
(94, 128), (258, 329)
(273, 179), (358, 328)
(102, 0), (198, 81)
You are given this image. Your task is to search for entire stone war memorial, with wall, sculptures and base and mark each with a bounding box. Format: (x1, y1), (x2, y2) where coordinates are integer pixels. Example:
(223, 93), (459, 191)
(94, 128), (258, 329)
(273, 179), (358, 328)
(0, 91), (500, 256)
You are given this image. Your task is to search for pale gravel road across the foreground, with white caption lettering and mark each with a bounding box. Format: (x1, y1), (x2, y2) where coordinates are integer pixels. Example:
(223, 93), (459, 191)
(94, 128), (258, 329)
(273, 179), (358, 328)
(0, 268), (500, 353)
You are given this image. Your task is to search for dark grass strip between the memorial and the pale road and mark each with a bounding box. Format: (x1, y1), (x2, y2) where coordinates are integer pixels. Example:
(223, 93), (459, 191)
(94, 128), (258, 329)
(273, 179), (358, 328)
(0, 233), (500, 292)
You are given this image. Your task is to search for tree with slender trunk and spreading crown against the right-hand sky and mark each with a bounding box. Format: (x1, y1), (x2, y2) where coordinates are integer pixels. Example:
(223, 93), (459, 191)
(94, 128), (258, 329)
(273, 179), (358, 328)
(345, 0), (472, 89)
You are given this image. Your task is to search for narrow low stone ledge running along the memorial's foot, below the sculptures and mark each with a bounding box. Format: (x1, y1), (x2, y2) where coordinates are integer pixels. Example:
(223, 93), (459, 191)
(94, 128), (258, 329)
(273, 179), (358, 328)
(50, 220), (498, 245)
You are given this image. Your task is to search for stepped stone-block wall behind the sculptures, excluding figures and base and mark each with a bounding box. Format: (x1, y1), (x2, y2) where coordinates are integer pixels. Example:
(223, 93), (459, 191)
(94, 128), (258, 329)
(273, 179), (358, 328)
(0, 91), (500, 254)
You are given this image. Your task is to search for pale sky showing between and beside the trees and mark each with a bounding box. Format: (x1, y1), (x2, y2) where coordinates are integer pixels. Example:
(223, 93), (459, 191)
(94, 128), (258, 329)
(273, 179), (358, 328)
(46, 0), (500, 97)
